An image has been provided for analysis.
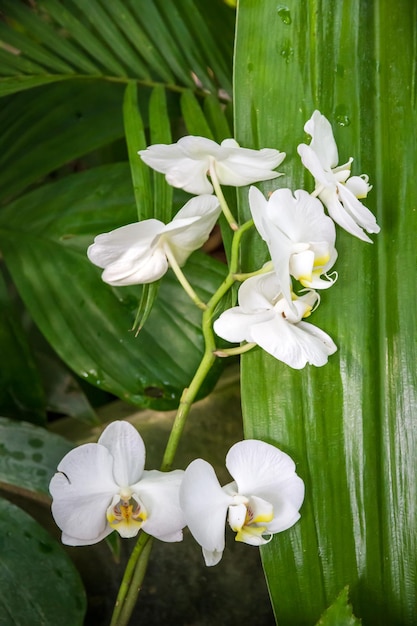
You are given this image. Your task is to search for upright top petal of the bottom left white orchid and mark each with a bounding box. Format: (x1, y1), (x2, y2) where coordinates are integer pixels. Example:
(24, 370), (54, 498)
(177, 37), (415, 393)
(98, 421), (145, 487)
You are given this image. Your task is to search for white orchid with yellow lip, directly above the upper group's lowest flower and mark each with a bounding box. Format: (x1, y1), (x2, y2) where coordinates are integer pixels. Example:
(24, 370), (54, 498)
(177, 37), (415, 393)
(249, 187), (337, 303)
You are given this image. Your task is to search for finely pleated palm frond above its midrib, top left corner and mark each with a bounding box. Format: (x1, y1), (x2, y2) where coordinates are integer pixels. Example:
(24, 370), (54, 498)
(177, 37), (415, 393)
(0, 0), (234, 95)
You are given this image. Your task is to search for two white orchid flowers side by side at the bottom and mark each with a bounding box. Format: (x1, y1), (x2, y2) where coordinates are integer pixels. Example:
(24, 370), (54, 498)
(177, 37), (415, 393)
(50, 422), (304, 565)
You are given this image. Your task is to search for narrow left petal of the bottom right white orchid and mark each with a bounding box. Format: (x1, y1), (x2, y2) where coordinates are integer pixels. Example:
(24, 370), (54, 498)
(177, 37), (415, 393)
(180, 459), (233, 565)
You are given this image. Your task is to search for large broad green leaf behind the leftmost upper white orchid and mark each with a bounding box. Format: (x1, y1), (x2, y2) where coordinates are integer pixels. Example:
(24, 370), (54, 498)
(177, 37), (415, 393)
(0, 163), (225, 408)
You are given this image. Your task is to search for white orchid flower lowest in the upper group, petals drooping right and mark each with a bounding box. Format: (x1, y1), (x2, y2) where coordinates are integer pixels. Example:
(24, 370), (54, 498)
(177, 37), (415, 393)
(213, 272), (337, 369)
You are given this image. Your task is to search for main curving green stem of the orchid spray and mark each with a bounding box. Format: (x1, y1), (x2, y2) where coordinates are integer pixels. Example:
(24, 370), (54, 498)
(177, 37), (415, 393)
(110, 220), (253, 626)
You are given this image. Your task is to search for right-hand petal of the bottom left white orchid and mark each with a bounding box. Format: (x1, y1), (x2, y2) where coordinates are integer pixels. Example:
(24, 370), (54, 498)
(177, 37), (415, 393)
(136, 470), (185, 541)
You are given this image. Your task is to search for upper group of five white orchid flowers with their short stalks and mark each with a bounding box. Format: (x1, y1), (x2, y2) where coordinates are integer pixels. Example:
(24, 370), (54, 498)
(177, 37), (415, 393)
(87, 111), (379, 369)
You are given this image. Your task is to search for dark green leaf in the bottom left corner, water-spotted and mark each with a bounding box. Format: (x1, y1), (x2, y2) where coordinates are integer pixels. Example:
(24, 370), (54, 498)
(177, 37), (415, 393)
(0, 500), (86, 626)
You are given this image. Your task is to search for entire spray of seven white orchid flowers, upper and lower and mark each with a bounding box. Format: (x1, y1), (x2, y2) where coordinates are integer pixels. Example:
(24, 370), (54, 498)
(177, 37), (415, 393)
(73, 111), (379, 565)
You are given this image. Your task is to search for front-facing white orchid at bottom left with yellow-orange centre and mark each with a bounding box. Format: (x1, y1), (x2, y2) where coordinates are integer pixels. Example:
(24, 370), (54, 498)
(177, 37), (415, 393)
(49, 422), (185, 546)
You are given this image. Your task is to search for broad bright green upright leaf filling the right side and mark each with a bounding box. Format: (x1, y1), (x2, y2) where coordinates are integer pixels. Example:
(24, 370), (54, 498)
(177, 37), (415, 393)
(235, 0), (417, 626)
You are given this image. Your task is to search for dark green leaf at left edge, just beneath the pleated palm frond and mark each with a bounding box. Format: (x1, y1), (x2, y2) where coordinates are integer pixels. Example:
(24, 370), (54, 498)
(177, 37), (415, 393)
(0, 81), (123, 198)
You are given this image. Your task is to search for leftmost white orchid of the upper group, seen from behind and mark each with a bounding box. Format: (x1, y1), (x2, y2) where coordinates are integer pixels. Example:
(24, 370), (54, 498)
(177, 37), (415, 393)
(87, 195), (221, 286)
